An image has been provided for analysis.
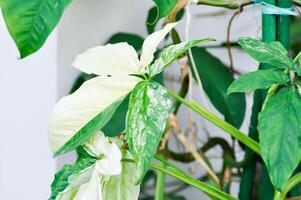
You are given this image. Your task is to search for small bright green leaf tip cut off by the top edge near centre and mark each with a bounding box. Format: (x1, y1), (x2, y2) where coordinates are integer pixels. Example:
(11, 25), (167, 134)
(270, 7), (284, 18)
(153, 0), (178, 22)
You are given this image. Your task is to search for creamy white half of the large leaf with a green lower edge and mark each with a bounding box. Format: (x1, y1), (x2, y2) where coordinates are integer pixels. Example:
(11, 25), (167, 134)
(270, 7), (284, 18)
(49, 76), (139, 152)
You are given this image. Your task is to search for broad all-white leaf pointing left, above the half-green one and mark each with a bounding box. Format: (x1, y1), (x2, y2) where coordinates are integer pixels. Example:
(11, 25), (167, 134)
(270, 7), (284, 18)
(72, 42), (139, 76)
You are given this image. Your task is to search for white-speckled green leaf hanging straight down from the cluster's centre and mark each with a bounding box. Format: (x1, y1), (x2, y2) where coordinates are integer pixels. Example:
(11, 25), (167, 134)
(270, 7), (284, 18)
(126, 81), (172, 183)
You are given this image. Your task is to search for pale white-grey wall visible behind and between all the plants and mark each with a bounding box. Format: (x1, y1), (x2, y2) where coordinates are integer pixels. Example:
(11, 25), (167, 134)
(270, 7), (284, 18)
(0, 0), (276, 200)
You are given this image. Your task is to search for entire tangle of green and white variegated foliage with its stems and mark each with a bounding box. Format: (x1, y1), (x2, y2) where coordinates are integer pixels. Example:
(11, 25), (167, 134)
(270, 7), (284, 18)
(0, 0), (301, 200)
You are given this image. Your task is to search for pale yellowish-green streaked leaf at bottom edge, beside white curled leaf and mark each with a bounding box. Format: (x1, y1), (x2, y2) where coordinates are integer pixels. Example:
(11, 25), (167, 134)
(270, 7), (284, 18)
(103, 153), (140, 200)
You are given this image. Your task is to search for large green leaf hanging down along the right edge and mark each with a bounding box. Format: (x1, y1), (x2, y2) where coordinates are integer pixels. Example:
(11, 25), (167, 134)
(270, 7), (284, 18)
(258, 87), (301, 191)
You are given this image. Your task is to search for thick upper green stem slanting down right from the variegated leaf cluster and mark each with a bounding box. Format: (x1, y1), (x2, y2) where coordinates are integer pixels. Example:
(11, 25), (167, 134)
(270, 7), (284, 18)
(168, 90), (260, 155)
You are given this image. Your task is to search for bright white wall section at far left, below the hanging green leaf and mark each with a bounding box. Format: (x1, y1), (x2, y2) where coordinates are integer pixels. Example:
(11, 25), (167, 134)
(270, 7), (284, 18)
(0, 13), (57, 200)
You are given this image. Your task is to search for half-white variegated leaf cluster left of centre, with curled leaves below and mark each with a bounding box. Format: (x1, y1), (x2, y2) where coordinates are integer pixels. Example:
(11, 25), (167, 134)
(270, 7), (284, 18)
(49, 23), (216, 200)
